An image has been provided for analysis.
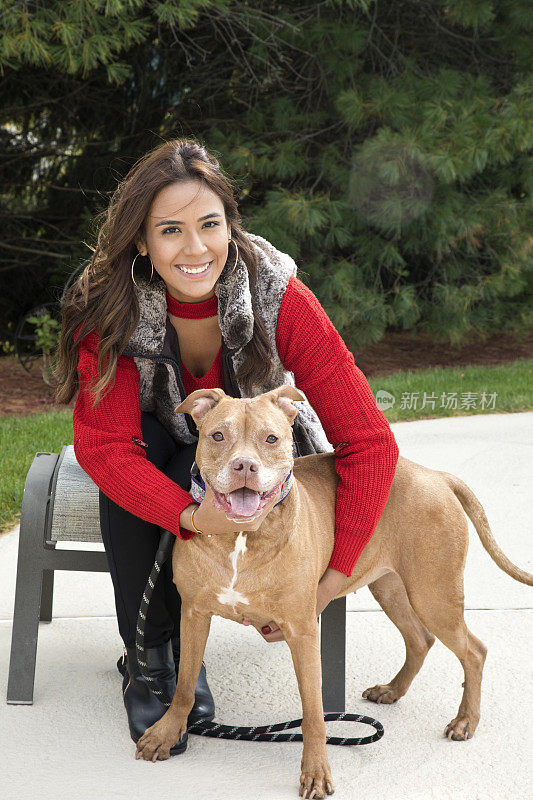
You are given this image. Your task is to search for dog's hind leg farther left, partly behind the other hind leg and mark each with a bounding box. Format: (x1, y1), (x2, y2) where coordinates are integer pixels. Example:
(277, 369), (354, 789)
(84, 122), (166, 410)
(363, 572), (435, 703)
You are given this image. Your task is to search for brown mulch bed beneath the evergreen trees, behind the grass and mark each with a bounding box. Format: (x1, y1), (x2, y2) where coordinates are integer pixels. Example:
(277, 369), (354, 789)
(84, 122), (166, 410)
(0, 331), (533, 417)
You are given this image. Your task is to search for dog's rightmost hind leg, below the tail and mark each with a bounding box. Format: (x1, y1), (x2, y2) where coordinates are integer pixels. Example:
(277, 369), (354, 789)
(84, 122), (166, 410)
(407, 574), (487, 740)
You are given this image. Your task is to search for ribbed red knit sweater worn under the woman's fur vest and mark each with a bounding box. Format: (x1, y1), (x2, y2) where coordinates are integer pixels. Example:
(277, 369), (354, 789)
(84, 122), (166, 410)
(73, 276), (399, 576)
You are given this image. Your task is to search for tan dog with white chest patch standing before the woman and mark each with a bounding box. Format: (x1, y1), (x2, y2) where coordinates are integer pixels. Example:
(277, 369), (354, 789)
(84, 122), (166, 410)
(137, 386), (533, 797)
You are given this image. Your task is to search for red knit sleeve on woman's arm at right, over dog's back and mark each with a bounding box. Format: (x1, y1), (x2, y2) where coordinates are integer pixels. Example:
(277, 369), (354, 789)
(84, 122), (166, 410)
(276, 277), (399, 583)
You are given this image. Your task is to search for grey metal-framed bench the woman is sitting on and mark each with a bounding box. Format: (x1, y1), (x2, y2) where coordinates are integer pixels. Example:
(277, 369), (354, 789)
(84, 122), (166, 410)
(7, 445), (346, 712)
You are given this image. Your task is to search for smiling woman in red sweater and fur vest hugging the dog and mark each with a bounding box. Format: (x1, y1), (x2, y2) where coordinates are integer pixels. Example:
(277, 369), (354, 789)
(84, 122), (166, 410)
(55, 139), (398, 754)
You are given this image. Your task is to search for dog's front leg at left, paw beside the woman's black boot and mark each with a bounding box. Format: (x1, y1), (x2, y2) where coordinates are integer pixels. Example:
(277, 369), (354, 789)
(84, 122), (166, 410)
(135, 599), (211, 761)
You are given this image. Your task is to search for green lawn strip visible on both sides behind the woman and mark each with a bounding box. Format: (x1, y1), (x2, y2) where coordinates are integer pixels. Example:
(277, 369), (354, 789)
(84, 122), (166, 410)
(0, 360), (533, 533)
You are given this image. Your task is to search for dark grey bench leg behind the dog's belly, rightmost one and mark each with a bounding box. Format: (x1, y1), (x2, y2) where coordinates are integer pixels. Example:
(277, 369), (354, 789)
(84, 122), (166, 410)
(320, 597), (346, 713)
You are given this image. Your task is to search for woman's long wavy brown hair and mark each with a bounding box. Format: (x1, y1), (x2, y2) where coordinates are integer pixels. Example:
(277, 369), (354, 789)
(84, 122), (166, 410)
(53, 139), (272, 408)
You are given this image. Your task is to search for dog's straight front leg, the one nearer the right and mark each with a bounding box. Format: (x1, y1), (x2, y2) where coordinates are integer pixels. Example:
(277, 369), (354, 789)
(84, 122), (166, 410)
(280, 620), (333, 798)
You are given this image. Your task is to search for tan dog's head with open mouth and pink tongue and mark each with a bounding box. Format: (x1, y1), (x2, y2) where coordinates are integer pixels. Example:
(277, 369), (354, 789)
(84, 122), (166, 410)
(174, 386), (305, 521)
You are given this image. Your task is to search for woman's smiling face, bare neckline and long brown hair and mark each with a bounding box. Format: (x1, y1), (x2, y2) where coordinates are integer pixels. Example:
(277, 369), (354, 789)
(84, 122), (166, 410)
(54, 139), (271, 407)
